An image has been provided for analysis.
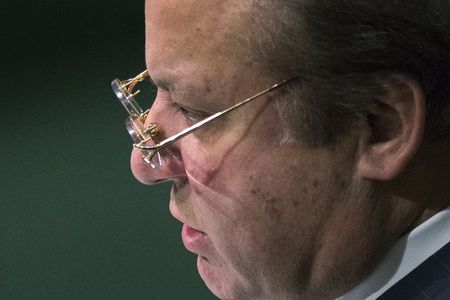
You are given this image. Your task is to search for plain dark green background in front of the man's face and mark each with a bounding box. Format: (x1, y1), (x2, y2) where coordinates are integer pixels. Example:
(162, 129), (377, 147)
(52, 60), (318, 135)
(0, 0), (214, 299)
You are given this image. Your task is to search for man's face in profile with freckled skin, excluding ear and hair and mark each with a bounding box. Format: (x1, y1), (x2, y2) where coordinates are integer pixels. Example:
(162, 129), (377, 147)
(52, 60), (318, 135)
(131, 0), (386, 299)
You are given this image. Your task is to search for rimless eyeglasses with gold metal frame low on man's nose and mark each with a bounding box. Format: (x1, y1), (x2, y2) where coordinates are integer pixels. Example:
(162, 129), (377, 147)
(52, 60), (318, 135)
(111, 70), (297, 168)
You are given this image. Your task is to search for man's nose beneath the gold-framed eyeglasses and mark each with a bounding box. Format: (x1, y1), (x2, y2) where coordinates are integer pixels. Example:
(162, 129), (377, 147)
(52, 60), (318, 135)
(130, 96), (186, 184)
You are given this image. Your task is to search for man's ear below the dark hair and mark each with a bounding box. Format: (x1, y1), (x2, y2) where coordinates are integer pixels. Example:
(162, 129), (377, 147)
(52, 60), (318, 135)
(357, 74), (426, 180)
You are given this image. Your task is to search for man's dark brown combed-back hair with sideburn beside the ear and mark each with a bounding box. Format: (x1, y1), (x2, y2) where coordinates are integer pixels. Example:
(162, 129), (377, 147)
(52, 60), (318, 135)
(246, 0), (450, 146)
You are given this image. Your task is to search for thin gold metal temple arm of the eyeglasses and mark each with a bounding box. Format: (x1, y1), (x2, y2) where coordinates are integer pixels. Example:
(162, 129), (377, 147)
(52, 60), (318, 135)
(133, 77), (297, 151)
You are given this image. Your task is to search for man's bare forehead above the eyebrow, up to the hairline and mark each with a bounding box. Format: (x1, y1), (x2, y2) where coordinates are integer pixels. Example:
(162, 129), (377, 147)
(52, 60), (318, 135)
(146, 0), (250, 77)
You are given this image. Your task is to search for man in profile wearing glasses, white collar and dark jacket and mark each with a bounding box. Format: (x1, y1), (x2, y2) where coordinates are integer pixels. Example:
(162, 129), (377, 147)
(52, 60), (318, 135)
(114, 0), (450, 299)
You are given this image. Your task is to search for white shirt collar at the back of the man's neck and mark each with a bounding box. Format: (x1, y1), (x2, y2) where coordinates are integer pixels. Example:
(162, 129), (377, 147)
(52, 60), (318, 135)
(337, 207), (450, 300)
